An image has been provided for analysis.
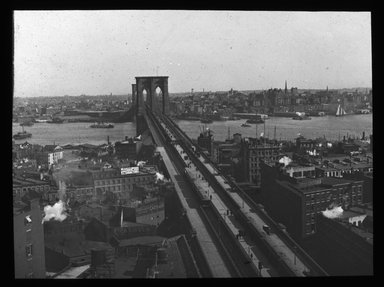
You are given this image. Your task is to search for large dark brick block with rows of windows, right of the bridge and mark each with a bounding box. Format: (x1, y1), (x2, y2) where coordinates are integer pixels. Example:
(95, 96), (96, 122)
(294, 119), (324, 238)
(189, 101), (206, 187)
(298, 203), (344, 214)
(261, 162), (363, 241)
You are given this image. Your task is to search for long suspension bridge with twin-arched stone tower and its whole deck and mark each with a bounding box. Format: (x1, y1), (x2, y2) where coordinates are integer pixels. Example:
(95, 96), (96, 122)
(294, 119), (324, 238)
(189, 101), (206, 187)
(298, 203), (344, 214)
(132, 76), (328, 277)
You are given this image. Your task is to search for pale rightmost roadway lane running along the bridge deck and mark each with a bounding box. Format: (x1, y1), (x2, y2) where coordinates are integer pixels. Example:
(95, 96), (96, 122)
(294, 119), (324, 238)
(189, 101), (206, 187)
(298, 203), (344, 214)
(160, 112), (327, 276)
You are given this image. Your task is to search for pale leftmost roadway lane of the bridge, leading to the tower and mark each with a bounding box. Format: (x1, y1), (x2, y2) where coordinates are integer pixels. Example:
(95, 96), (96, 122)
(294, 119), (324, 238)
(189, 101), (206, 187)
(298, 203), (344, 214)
(146, 111), (233, 278)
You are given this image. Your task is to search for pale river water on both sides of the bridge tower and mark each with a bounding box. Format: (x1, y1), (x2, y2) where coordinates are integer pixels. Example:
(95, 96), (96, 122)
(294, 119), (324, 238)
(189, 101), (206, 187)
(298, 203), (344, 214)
(12, 114), (373, 145)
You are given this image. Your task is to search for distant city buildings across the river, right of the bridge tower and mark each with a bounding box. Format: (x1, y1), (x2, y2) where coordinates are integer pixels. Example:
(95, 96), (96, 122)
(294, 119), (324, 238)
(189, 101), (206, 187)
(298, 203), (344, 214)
(170, 87), (372, 116)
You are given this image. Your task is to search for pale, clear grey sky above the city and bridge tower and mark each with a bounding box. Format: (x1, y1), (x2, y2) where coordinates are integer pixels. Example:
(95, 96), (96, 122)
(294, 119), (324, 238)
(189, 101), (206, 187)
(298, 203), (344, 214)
(14, 10), (372, 97)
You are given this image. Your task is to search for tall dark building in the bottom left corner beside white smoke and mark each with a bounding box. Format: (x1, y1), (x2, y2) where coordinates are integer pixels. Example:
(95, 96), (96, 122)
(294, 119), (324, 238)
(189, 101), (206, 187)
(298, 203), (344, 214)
(13, 199), (46, 278)
